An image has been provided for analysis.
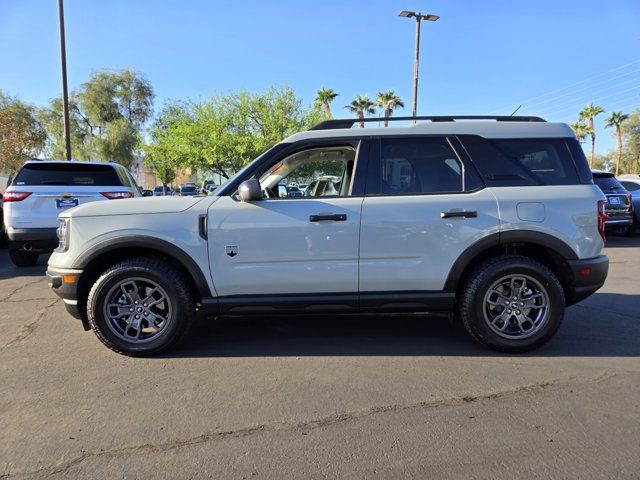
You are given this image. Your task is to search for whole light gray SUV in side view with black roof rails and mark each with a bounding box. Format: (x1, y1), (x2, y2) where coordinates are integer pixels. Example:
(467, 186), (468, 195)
(47, 117), (608, 355)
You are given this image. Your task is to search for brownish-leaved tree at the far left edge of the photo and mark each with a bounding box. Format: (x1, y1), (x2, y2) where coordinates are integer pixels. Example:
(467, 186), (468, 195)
(0, 91), (46, 178)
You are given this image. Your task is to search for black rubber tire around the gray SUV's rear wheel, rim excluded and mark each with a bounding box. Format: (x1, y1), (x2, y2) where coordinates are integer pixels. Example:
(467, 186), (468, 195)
(460, 255), (565, 353)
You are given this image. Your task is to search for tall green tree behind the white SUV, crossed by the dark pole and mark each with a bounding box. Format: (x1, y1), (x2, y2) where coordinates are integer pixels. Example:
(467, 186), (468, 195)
(40, 69), (154, 166)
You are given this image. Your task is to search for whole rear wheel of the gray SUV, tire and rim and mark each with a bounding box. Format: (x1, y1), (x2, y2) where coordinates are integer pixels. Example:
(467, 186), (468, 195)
(460, 256), (565, 353)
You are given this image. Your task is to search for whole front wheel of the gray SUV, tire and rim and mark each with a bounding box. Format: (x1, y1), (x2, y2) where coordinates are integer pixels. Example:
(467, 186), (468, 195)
(87, 258), (196, 356)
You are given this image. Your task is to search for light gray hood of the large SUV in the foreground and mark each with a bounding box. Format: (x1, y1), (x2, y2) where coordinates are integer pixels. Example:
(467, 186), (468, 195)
(60, 197), (211, 218)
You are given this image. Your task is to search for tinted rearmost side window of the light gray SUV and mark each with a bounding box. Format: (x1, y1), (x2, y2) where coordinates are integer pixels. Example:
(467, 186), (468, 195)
(490, 138), (580, 185)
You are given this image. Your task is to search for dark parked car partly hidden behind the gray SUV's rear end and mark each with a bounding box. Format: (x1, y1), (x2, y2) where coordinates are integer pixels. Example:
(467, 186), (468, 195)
(593, 170), (633, 235)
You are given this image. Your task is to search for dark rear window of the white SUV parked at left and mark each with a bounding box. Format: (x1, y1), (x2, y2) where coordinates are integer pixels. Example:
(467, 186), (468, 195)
(13, 163), (123, 187)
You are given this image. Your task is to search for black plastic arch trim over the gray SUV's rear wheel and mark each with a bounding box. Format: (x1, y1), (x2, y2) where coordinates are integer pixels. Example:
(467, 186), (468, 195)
(444, 230), (578, 291)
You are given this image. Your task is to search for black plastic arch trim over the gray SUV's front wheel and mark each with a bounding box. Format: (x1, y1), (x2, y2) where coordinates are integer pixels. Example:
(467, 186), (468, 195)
(72, 235), (212, 298)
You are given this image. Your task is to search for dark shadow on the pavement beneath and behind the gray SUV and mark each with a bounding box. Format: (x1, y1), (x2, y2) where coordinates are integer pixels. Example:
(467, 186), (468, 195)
(163, 293), (640, 358)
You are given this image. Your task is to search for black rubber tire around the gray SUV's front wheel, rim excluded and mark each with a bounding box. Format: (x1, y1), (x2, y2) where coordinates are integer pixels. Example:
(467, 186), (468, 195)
(87, 258), (196, 356)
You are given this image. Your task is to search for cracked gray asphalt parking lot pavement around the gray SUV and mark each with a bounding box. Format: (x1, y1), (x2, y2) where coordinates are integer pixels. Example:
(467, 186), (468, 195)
(0, 236), (640, 479)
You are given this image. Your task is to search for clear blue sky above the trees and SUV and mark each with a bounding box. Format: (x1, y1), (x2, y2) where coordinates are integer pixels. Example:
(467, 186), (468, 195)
(0, 0), (640, 150)
